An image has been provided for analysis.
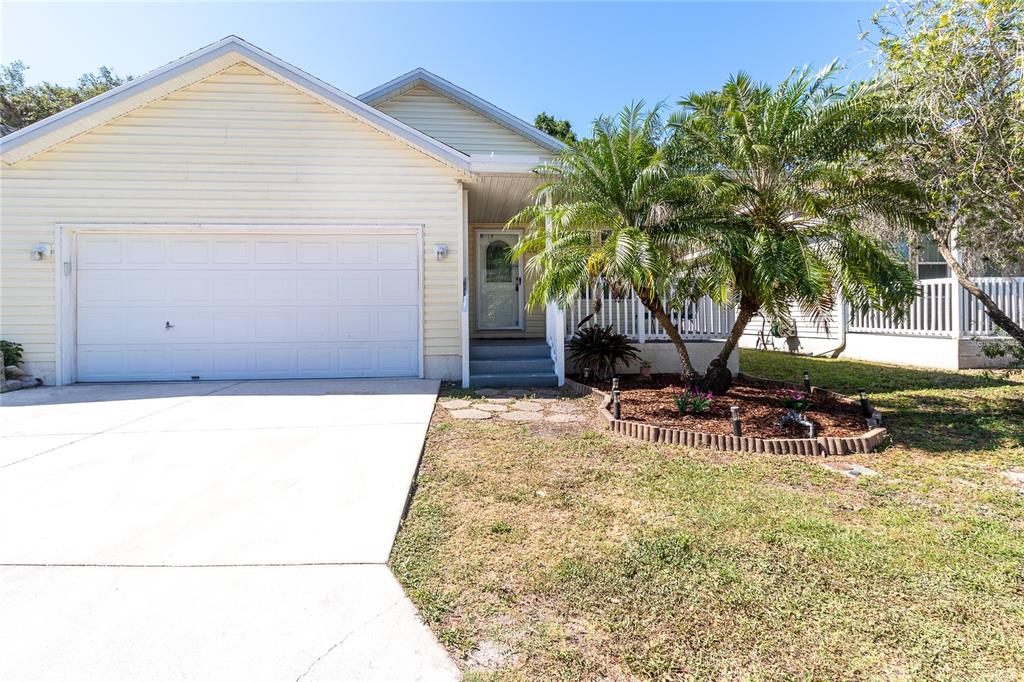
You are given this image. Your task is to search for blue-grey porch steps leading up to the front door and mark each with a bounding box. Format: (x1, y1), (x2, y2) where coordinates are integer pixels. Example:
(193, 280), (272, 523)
(469, 339), (558, 388)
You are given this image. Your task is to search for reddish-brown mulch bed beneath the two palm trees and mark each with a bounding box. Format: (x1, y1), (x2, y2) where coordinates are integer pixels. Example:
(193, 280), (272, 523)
(574, 374), (867, 438)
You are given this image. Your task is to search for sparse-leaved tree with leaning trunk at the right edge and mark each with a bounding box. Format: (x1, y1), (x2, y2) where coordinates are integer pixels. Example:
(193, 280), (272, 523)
(865, 0), (1024, 343)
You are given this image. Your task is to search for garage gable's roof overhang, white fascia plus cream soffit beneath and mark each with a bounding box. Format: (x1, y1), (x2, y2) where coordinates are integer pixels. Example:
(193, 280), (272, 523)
(0, 36), (471, 176)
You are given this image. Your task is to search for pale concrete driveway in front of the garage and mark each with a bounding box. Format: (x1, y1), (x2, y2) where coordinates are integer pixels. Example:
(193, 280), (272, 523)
(0, 380), (458, 682)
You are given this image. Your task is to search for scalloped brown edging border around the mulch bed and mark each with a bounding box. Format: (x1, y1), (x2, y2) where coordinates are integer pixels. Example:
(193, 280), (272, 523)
(563, 374), (888, 455)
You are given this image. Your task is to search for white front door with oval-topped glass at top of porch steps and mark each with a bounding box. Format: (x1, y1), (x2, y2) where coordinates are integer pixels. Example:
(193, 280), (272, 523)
(476, 230), (523, 331)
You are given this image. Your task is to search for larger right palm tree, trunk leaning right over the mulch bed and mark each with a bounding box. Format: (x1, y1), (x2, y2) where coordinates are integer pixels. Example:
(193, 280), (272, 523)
(665, 62), (921, 393)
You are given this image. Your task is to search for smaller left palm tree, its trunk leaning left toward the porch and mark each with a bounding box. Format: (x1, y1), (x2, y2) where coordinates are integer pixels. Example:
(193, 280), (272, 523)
(508, 102), (696, 381)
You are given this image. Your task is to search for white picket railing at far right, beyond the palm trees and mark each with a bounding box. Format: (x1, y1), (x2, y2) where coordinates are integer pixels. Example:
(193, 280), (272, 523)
(848, 278), (1024, 337)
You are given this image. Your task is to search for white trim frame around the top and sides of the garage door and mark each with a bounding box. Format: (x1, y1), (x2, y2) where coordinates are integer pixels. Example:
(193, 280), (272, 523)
(53, 223), (425, 385)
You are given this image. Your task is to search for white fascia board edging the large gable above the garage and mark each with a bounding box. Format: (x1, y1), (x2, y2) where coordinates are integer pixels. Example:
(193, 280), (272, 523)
(0, 36), (470, 173)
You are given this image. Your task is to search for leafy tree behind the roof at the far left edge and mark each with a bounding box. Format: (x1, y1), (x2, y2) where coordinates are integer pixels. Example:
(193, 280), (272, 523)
(0, 61), (131, 129)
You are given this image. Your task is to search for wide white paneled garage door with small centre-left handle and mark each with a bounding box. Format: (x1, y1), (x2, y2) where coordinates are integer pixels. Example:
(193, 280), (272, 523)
(77, 233), (420, 381)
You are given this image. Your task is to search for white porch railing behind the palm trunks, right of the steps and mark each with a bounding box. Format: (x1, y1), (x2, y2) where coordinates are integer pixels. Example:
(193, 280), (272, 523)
(564, 288), (736, 343)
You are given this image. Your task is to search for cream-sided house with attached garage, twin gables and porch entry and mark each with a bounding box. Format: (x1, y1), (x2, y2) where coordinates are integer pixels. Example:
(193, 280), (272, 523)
(0, 37), (737, 385)
